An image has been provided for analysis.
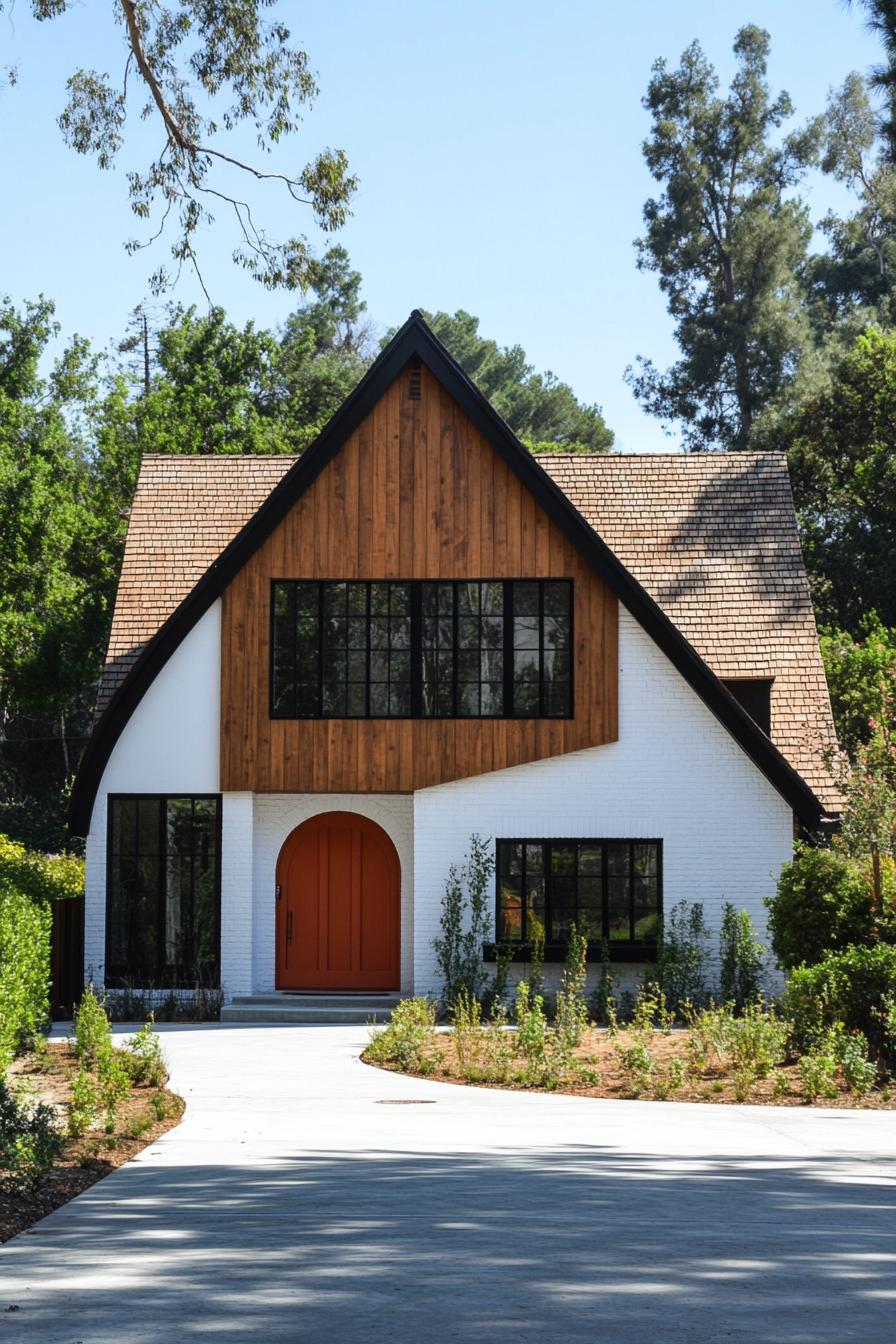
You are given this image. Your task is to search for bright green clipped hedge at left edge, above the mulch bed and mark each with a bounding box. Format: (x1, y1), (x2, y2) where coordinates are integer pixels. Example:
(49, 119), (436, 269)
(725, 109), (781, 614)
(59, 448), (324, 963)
(0, 881), (52, 1075)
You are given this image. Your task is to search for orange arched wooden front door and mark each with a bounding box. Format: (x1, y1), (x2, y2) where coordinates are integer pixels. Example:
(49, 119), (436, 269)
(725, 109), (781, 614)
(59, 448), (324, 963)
(277, 812), (400, 989)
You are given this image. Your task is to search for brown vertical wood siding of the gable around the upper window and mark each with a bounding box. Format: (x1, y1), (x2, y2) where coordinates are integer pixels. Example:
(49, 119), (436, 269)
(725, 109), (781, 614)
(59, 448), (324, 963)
(220, 367), (618, 793)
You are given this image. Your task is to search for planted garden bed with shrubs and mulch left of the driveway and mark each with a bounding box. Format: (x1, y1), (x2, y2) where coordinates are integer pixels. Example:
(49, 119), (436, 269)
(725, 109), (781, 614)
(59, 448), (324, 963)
(0, 993), (184, 1242)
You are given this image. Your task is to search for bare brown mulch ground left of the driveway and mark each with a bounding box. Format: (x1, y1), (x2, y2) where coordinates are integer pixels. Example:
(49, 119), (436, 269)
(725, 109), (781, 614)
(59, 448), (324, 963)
(0, 1040), (184, 1243)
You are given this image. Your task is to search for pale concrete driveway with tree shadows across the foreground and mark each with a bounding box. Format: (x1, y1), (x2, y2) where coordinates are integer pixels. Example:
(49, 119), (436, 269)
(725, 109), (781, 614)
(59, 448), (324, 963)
(0, 1027), (896, 1344)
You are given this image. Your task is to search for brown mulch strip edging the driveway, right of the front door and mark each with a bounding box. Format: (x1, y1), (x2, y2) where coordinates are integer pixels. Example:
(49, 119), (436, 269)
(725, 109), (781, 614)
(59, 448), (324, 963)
(361, 1030), (896, 1110)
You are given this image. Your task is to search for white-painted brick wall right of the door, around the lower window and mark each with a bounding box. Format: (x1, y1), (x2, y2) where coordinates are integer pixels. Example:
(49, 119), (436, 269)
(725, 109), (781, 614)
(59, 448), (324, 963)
(414, 610), (793, 993)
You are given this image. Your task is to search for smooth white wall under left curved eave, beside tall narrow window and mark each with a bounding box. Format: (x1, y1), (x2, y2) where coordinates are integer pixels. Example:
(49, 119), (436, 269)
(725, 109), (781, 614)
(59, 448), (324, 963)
(85, 602), (220, 984)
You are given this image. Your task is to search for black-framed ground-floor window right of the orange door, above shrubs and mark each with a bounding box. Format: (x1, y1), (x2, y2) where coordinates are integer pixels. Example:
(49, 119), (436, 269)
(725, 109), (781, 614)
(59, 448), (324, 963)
(496, 840), (662, 948)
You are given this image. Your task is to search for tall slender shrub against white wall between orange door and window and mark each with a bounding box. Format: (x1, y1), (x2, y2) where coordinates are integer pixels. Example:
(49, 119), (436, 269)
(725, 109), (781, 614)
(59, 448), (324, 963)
(433, 835), (494, 1005)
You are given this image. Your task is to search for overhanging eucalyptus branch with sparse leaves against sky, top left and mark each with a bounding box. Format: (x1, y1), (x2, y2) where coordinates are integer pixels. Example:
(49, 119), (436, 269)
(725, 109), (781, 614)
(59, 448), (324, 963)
(0, 0), (357, 297)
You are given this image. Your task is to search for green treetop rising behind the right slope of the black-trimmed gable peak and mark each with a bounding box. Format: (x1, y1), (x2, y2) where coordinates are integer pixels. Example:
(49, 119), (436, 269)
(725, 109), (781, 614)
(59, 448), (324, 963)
(423, 309), (614, 453)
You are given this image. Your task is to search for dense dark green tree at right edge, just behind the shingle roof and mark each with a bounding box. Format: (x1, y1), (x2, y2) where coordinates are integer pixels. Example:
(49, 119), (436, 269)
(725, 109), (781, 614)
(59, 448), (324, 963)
(780, 328), (896, 633)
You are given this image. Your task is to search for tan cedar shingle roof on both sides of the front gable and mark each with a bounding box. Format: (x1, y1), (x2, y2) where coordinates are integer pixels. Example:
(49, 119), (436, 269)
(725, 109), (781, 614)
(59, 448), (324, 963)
(97, 453), (837, 808)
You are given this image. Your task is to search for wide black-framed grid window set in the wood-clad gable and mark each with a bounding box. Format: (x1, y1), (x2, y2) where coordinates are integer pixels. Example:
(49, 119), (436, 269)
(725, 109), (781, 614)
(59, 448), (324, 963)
(270, 579), (572, 719)
